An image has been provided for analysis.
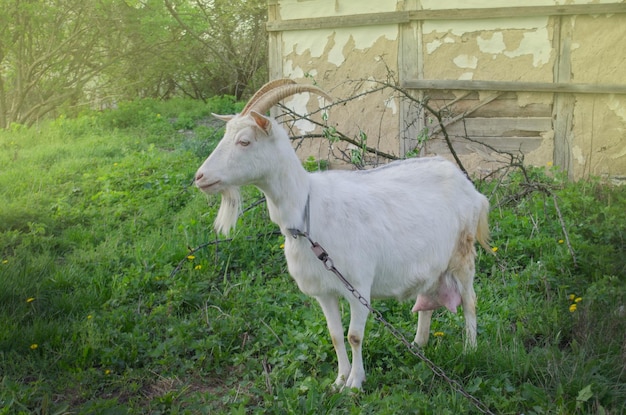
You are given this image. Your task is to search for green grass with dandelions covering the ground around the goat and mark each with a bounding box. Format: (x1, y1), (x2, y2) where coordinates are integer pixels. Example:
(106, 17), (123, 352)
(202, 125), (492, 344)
(0, 99), (626, 414)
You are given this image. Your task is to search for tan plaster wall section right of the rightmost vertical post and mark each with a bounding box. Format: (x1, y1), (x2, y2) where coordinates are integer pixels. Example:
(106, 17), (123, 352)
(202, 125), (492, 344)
(572, 14), (626, 178)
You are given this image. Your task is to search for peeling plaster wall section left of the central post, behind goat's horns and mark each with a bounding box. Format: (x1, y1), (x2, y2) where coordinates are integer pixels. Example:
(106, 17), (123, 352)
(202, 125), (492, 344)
(279, 0), (398, 165)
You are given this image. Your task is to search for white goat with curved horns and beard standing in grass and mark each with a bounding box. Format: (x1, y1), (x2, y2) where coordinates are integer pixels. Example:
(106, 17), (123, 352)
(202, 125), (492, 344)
(196, 79), (489, 388)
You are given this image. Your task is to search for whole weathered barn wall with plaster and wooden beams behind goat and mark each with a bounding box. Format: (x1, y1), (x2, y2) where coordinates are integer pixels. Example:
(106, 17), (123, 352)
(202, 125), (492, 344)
(268, 0), (626, 180)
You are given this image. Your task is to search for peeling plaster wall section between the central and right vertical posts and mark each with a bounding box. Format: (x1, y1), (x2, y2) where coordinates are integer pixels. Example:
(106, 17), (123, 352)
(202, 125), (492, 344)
(422, 17), (557, 173)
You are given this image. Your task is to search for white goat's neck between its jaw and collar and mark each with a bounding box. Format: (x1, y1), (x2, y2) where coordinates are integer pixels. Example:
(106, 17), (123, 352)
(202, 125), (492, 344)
(258, 154), (310, 232)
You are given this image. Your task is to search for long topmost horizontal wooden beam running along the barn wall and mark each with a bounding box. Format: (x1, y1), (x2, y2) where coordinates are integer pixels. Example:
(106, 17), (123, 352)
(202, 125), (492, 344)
(265, 3), (626, 32)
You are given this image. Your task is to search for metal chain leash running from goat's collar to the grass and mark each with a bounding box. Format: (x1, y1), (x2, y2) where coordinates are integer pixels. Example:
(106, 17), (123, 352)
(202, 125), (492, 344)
(289, 229), (495, 415)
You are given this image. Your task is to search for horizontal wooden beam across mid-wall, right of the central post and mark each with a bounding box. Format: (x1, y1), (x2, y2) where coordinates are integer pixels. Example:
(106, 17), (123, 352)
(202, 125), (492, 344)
(401, 79), (626, 94)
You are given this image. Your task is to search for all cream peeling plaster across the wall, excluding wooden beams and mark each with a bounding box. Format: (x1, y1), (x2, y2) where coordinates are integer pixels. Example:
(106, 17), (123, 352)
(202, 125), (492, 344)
(270, 0), (626, 179)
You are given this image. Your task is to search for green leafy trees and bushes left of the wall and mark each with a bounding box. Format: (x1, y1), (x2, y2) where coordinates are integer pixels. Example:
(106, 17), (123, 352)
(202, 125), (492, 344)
(0, 0), (267, 128)
